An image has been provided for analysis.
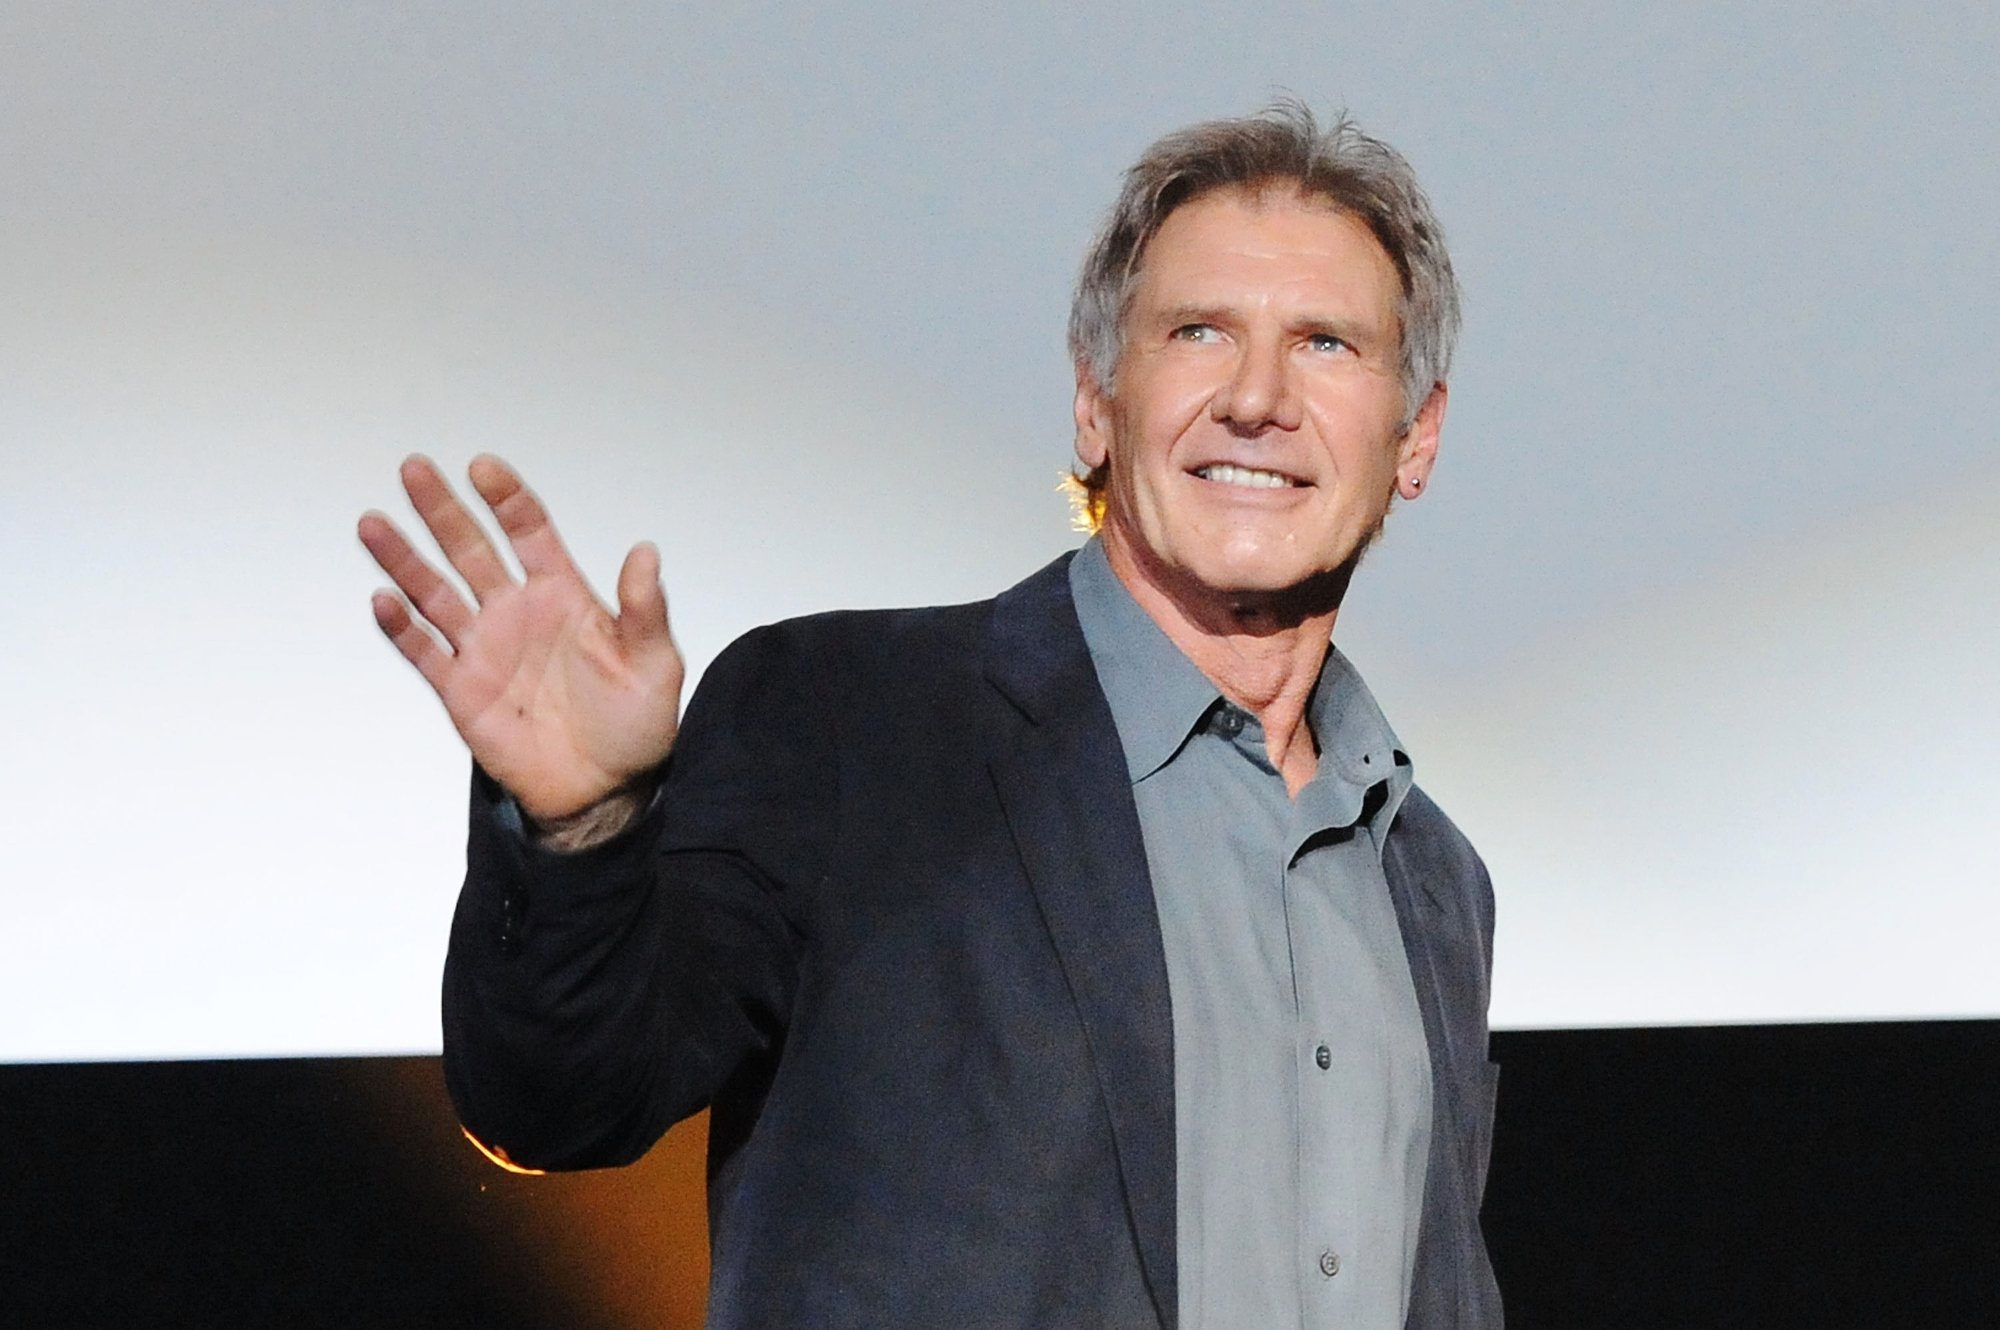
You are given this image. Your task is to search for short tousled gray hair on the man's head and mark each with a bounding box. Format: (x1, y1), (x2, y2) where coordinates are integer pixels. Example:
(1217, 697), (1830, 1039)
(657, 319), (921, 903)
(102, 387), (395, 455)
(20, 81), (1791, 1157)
(1070, 98), (1458, 428)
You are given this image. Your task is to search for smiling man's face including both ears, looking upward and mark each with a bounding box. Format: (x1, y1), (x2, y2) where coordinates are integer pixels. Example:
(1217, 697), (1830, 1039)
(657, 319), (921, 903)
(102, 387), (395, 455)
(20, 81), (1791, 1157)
(1076, 188), (1444, 604)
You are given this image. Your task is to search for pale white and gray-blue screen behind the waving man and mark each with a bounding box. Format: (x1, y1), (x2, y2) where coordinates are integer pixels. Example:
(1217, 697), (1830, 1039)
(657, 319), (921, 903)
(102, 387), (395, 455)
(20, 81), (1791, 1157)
(0, 4), (2000, 1060)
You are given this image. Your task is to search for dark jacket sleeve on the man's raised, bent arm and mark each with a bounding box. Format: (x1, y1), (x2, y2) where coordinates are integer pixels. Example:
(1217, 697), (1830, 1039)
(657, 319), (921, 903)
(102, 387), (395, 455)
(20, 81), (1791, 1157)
(444, 624), (838, 1168)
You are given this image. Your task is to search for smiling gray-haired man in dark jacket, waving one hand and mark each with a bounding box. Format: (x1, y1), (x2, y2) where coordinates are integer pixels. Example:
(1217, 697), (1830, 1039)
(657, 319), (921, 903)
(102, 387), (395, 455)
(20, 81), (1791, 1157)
(362, 106), (1500, 1330)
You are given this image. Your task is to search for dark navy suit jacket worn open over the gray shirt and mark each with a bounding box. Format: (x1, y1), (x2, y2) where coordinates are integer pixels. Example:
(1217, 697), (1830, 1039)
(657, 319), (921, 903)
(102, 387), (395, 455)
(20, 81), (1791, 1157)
(444, 560), (1500, 1330)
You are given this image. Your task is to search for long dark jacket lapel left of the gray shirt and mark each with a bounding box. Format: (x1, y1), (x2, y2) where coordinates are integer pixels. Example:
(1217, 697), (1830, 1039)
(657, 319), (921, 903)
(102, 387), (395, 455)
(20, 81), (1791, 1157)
(986, 558), (1178, 1330)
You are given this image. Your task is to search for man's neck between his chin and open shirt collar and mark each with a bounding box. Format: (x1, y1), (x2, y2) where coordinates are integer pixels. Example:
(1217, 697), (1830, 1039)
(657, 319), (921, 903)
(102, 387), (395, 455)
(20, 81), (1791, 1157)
(1104, 530), (1354, 796)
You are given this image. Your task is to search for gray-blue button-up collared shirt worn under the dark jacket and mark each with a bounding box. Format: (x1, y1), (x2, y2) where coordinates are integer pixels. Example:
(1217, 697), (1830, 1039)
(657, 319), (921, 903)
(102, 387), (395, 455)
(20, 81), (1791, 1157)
(1070, 540), (1430, 1330)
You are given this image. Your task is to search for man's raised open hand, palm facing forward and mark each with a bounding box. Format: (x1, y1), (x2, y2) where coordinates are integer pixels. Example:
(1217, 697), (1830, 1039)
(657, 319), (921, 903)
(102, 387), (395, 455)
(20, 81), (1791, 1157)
(358, 456), (684, 824)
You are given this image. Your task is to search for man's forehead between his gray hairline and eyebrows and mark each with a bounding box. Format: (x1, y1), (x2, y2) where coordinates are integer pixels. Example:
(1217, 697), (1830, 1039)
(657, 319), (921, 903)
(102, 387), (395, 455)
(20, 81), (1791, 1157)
(1132, 184), (1402, 316)
